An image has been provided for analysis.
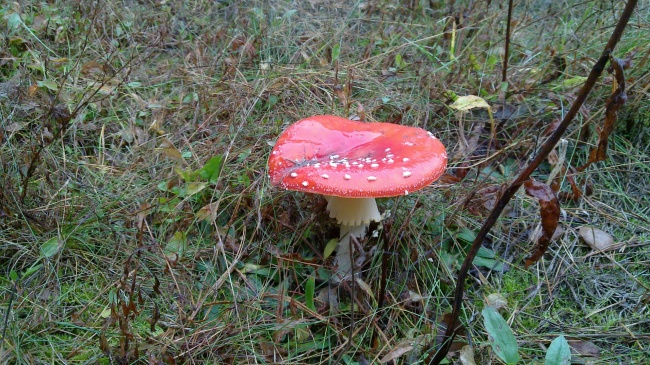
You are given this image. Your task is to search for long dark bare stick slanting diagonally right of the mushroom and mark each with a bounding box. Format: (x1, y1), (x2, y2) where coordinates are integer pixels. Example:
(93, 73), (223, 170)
(427, 0), (638, 365)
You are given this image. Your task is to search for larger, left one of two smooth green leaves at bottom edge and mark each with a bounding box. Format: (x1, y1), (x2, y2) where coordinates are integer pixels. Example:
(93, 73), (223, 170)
(481, 306), (519, 364)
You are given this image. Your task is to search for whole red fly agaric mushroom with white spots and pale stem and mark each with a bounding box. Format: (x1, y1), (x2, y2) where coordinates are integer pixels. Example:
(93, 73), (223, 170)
(269, 115), (447, 279)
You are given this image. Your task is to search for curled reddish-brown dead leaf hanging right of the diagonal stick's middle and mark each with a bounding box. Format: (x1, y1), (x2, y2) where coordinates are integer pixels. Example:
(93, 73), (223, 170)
(524, 180), (560, 267)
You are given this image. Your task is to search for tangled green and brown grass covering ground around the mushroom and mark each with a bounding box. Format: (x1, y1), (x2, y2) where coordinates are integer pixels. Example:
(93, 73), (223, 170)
(0, 0), (650, 364)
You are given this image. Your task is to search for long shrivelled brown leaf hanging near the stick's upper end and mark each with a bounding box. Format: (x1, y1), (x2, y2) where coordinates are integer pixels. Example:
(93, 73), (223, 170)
(577, 56), (627, 171)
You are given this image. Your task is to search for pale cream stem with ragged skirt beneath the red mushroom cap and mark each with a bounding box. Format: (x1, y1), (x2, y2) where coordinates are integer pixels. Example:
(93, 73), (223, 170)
(326, 196), (381, 281)
